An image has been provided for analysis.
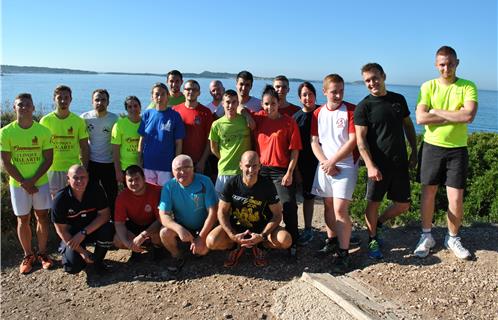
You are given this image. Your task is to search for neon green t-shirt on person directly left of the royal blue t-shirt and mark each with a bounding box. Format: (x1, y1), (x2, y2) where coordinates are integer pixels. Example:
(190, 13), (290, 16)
(111, 117), (140, 170)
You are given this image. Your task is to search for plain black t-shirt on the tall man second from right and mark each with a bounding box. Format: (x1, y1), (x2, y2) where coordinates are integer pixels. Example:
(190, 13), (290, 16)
(354, 91), (410, 170)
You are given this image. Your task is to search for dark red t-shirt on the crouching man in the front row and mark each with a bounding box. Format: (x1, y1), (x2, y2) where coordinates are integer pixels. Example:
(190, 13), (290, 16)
(114, 183), (161, 226)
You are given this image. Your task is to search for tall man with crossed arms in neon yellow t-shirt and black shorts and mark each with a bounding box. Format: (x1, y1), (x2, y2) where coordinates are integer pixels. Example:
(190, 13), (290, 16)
(414, 46), (477, 259)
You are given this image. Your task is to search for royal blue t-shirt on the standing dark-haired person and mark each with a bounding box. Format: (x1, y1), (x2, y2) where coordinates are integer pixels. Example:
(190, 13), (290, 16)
(138, 108), (185, 172)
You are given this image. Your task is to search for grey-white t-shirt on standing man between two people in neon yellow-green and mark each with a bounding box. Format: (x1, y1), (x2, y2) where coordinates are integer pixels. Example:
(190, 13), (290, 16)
(81, 110), (118, 163)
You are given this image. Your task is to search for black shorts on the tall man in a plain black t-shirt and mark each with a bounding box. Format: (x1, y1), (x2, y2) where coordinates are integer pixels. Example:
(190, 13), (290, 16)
(365, 167), (411, 202)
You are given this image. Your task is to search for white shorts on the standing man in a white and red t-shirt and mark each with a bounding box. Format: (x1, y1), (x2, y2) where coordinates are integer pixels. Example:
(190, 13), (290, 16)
(311, 165), (358, 200)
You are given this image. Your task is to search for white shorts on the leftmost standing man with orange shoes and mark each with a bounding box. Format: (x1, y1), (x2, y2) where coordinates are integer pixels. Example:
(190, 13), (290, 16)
(10, 183), (52, 217)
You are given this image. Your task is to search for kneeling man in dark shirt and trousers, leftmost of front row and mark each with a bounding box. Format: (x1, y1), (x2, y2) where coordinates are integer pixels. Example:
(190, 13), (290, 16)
(52, 164), (114, 273)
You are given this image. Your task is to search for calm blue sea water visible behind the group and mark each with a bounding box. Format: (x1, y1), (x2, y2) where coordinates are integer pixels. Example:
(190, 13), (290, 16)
(0, 74), (498, 132)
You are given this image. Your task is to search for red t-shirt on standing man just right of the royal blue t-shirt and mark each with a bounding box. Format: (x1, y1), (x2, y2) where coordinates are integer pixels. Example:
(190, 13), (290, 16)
(173, 103), (213, 163)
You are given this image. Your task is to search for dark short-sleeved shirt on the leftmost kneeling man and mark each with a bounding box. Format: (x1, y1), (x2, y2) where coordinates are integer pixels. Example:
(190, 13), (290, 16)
(51, 183), (109, 229)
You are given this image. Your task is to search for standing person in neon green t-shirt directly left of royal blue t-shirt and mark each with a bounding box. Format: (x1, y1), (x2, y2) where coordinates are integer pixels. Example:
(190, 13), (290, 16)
(111, 96), (142, 183)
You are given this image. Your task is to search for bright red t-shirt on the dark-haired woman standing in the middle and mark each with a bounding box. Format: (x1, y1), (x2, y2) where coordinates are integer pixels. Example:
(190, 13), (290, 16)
(253, 110), (302, 168)
